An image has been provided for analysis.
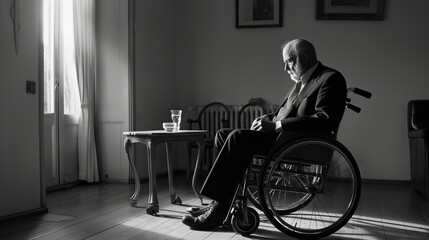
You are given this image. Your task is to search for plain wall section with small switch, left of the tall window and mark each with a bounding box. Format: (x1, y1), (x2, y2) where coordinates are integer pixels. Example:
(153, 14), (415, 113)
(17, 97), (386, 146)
(0, 0), (44, 219)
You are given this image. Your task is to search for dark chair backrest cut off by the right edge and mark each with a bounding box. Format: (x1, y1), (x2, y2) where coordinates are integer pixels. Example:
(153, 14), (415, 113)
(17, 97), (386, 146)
(407, 100), (429, 131)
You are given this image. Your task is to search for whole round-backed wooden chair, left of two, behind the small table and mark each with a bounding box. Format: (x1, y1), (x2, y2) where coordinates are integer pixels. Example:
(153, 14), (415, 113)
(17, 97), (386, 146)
(186, 102), (231, 182)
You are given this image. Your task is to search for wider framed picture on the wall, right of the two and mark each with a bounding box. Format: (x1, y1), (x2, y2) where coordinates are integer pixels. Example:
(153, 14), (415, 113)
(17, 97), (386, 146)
(316, 0), (384, 20)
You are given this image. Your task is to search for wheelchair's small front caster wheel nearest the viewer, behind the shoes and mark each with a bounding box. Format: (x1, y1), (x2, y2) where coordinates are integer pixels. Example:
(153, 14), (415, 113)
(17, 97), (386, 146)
(231, 207), (259, 236)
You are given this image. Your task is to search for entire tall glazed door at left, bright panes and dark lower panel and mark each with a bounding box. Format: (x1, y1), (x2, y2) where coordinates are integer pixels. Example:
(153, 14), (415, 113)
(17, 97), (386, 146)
(42, 0), (81, 189)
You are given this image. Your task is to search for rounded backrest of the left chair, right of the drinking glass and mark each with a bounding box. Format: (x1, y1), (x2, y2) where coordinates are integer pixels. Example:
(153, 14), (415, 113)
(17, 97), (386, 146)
(192, 102), (231, 138)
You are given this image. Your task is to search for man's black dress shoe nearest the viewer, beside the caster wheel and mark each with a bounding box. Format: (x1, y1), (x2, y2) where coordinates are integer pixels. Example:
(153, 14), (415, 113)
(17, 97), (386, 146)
(182, 206), (228, 231)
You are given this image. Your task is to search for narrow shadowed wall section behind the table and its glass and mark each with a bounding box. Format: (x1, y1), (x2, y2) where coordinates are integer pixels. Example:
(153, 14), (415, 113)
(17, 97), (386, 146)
(133, 0), (181, 178)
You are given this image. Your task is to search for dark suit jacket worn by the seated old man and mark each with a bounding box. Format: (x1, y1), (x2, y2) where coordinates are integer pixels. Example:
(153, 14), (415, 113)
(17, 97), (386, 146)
(271, 62), (347, 134)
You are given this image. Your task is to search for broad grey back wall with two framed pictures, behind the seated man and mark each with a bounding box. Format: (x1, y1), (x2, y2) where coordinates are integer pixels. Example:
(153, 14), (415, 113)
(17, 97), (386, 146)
(173, 0), (429, 180)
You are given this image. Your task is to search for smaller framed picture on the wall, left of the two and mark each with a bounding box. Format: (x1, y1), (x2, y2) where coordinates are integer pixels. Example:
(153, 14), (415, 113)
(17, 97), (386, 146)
(235, 0), (283, 28)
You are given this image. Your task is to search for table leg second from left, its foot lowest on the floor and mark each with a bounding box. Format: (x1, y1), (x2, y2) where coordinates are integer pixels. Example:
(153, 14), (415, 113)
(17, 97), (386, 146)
(146, 142), (159, 215)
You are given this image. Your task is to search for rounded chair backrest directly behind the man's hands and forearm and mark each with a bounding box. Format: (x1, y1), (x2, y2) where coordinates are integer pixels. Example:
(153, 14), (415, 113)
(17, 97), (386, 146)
(237, 102), (268, 129)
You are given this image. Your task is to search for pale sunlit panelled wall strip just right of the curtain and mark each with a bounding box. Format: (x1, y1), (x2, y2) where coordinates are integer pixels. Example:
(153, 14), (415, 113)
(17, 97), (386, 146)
(97, 0), (130, 182)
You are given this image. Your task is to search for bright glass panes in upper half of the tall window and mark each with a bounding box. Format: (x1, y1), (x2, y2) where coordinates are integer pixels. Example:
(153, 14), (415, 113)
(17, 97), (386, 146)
(43, 0), (81, 115)
